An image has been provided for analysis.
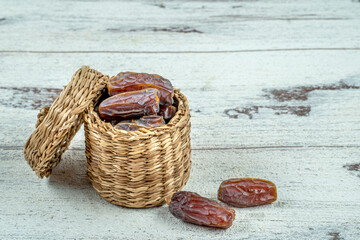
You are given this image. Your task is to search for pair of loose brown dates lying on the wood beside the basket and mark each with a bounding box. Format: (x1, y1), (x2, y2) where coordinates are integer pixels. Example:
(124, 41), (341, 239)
(169, 178), (277, 228)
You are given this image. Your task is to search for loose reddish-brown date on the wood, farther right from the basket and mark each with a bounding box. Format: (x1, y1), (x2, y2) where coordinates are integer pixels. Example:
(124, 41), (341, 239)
(218, 178), (277, 208)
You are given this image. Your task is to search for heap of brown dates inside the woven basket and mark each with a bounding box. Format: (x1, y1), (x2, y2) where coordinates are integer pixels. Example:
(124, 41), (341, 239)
(95, 72), (177, 131)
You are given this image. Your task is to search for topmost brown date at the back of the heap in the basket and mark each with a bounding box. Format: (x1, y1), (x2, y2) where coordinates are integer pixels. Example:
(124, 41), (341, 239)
(107, 72), (174, 105)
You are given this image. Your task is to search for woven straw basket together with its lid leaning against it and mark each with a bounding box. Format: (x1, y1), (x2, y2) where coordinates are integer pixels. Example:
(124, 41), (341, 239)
(24, 66), (191, 208)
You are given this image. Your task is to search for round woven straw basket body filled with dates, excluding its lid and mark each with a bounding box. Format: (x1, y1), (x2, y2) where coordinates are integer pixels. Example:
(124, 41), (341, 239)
(84, 90), (191, 208)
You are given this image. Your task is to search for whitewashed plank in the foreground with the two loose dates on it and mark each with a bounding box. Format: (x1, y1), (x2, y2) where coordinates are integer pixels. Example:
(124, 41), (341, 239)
(0, 148), (360, 239)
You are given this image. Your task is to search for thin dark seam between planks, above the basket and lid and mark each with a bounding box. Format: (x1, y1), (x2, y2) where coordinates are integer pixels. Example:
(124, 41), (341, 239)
(0, 47), (360, 54)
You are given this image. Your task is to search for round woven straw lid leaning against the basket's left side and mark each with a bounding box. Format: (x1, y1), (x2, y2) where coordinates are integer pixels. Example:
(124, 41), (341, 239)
(24, 66), (108, 178)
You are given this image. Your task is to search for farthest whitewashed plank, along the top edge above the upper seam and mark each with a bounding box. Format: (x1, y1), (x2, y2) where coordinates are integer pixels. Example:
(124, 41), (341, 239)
(0, 0), (360, 52)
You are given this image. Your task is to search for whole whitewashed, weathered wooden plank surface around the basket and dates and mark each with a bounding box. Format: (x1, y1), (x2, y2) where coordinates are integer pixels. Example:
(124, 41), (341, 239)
(0, 0), (360, 240)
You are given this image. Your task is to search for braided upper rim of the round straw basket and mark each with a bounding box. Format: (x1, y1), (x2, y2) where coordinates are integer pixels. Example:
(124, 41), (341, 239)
(84, 88), (190, 138)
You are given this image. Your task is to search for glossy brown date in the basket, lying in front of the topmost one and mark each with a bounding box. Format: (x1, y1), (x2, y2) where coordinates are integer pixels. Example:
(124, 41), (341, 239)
(99, 88), (159, 120)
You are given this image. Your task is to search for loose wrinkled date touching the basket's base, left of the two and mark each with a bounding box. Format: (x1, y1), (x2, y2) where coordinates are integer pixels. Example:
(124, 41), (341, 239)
(169, 191), (235, 228)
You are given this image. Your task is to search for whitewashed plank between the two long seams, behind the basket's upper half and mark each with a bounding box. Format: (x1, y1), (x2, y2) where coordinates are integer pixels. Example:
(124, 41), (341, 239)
(0, 51), (360, 149)
